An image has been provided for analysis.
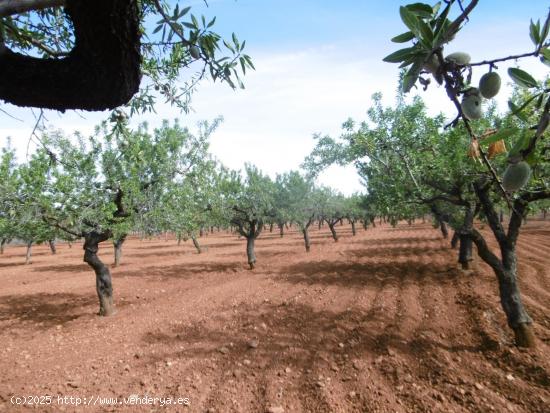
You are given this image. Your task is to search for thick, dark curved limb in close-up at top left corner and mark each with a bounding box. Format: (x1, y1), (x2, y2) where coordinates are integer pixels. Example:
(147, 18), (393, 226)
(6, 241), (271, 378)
(0, 0), (141, 111)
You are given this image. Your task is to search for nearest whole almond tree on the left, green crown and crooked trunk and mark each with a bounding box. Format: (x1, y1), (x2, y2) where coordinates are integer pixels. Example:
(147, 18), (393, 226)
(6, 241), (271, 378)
(42, 122), (213, 316)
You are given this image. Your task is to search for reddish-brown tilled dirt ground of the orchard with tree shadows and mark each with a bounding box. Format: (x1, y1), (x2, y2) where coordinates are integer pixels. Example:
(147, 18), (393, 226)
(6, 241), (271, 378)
(0, 220), (550, 413)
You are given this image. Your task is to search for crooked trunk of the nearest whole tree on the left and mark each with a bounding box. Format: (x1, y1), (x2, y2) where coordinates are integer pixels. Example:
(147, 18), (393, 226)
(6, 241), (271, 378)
(84, 231), (116, 316)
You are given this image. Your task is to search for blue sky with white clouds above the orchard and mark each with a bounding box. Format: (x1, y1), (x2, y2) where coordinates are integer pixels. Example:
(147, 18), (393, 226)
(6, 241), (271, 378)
(0, 0), (549, 194)
